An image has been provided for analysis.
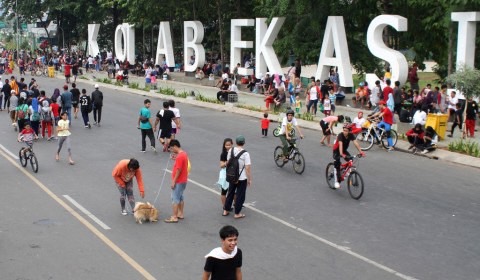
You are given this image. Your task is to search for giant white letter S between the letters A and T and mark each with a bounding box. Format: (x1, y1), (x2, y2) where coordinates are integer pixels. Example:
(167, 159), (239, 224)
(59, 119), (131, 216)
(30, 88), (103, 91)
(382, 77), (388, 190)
(367, 15), (408, 85)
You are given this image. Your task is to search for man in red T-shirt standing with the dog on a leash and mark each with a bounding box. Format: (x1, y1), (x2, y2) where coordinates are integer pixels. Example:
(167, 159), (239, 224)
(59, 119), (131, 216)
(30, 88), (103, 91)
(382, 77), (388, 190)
(165, 139), (188, 223)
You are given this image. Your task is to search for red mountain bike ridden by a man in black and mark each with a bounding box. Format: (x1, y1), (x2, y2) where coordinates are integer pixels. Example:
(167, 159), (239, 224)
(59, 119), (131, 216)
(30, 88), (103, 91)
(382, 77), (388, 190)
(325, 154), (364, 200)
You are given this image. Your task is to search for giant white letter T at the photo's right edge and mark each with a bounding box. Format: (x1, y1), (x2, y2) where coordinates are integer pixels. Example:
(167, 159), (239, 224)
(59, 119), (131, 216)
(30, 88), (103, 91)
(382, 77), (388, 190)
(452, 12), (480, 70)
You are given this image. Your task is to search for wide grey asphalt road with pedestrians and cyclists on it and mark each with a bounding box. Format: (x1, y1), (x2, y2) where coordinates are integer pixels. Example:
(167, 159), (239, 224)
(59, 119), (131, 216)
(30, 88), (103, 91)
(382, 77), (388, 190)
(0, 75), (480, 280)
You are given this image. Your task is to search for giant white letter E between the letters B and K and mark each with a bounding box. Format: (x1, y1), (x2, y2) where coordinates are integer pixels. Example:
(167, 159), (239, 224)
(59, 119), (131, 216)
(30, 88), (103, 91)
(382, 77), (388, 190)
(230, 19), (255, 75)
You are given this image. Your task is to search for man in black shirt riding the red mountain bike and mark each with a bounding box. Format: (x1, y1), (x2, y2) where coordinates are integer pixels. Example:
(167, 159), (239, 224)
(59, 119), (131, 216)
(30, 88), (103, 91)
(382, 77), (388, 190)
(333, 123), (365, 189)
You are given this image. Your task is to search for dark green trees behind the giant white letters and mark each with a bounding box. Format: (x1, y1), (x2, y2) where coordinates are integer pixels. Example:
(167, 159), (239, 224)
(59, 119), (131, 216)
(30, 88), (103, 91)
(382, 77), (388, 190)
(0, 0), (480, 77)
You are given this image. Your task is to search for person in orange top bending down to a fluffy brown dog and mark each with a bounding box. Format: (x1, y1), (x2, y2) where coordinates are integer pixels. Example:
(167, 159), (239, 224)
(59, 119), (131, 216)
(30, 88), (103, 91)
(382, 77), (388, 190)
(112, 158), (145, 216)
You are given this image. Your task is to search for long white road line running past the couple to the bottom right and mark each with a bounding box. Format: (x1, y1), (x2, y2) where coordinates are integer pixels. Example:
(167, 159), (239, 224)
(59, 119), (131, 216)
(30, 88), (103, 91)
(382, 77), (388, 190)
(167, 170), (418, 280)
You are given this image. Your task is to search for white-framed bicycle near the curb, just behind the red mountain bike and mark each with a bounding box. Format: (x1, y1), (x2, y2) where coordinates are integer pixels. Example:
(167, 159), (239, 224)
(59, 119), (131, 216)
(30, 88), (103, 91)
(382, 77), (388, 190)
(356, 120), (398, 151)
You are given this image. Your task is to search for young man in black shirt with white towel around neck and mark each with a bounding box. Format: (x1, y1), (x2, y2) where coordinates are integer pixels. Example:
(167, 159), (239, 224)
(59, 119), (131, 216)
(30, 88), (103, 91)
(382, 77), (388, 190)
(202, 225), (242, 280)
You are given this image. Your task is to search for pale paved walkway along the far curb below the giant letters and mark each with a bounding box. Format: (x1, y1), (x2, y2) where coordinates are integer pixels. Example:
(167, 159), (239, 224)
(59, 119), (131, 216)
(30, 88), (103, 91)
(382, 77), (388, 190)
(54, 69), (480, 168)
